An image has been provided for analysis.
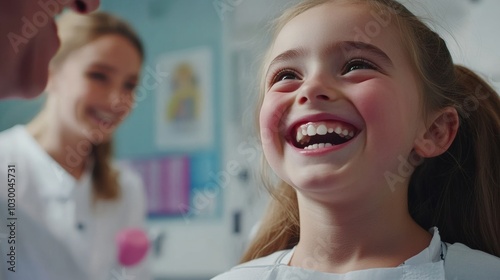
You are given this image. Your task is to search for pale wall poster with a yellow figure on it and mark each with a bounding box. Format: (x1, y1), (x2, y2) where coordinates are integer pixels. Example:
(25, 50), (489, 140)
(155, 47), (215, 152)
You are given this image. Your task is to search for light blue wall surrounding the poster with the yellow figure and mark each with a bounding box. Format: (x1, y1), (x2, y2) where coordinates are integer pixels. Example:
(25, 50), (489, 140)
(102, 0), (222, 158)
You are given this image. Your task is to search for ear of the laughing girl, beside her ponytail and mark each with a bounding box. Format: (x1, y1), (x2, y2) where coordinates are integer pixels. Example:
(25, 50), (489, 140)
(414, 107), (459, 158)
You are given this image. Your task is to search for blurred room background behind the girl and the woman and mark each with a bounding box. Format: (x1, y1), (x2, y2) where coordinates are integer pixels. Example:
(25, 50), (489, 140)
(0, 0), (500, 280)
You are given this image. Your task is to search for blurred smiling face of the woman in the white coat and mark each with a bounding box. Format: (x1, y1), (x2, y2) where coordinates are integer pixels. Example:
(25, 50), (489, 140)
(48, 34), (142, 141)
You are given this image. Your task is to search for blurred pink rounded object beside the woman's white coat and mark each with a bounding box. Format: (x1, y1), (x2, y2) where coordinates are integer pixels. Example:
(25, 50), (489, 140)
(116, 228), (149, 266)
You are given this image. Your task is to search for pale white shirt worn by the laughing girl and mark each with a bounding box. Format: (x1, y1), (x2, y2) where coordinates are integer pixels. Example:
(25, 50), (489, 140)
(212, 228), (500, 280)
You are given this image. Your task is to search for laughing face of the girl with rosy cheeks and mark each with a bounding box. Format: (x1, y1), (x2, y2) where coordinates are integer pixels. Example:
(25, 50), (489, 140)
(260, 3), (424, 201)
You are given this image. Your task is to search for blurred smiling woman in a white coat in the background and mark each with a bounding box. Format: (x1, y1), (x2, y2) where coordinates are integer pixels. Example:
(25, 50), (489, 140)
(0, 12), (149, 280)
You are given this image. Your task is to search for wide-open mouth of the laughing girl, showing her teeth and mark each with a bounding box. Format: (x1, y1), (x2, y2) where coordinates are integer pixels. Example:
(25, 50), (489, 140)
(289, 120), (359, 150)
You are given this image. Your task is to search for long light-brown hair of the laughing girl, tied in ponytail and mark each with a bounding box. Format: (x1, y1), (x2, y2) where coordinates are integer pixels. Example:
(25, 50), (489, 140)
(242, 0), (500, 262)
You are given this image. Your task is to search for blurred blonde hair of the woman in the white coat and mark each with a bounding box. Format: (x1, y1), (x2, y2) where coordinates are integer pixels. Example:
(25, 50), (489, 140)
(50, 12), (144, 200)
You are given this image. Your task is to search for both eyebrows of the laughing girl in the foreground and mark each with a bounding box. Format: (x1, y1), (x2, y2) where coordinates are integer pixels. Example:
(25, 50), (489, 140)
(268, 41), (393, 69)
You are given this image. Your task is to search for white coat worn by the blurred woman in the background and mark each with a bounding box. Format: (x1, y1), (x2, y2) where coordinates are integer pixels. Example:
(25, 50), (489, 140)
(0, 125), (150, 280)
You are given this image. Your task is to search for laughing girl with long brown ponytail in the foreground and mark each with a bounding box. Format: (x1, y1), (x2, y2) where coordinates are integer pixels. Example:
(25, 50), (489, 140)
(215, 0), (500, 280)
